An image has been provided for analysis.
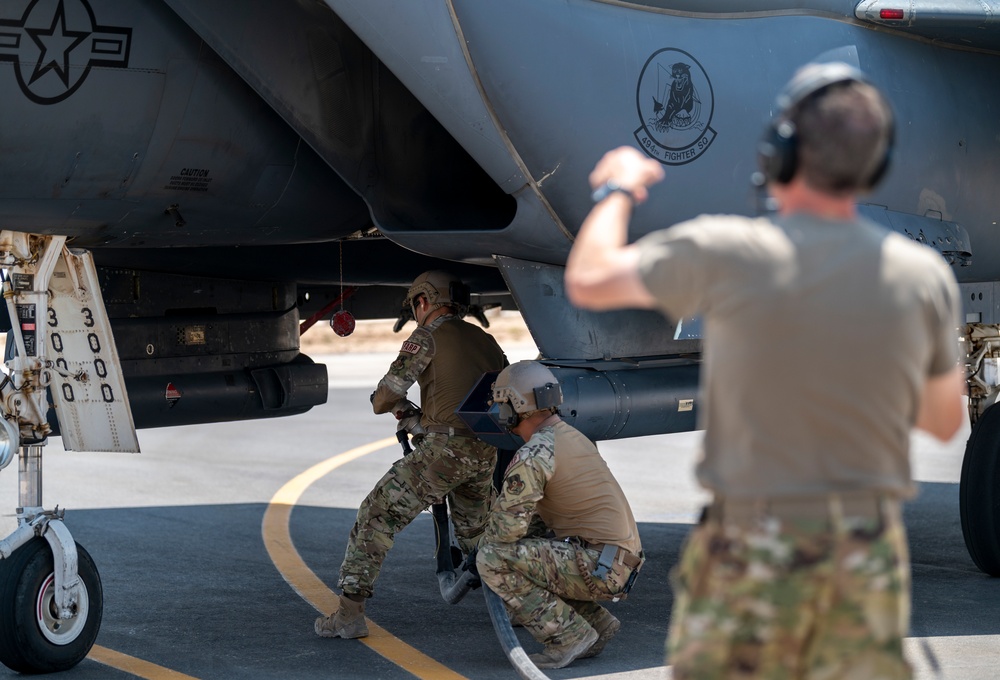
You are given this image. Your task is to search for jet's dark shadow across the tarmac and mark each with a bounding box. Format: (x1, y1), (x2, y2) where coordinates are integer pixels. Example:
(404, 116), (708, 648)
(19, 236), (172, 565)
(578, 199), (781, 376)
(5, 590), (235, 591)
(0, 483), (1000, 680)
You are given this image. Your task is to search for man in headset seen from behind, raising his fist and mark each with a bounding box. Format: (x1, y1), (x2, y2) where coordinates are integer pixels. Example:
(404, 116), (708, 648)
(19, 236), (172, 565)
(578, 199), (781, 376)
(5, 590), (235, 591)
(566, 63), (964, 680)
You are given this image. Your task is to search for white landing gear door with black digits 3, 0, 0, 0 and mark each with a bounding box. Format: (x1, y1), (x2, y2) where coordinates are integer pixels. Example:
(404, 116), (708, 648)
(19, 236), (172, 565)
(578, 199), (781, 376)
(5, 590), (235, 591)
(47, 248), (139, 453)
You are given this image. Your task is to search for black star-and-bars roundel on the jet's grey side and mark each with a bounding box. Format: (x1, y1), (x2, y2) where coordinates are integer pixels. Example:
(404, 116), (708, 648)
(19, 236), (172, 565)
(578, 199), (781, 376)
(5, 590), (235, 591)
(0, 0), (132, 104)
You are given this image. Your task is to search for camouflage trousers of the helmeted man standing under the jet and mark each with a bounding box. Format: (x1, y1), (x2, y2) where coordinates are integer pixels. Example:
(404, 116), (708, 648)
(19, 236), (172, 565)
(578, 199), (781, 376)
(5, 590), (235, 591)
(338, 433), (497, 597)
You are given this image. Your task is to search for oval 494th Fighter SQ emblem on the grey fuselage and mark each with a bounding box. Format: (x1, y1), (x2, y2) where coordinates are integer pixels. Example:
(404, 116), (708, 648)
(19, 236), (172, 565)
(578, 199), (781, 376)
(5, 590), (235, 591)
(635, 47), (716, 165)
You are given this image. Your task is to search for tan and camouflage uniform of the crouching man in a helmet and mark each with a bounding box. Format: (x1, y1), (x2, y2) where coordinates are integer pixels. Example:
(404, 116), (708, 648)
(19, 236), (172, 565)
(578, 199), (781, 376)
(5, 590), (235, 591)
(477, 418), (642, 645)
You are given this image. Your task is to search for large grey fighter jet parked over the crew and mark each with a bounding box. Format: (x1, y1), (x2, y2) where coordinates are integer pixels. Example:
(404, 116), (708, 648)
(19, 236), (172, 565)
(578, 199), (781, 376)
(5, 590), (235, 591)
(0, 0), (1000, 672)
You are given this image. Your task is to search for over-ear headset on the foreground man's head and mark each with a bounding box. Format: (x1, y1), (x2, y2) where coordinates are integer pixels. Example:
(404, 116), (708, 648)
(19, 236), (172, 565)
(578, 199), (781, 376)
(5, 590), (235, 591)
(757, 62), (895, 191)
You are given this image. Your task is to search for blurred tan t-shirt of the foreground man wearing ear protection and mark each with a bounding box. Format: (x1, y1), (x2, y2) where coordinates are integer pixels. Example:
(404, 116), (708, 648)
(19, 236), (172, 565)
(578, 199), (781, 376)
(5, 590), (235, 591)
(637, 215), (961, 498)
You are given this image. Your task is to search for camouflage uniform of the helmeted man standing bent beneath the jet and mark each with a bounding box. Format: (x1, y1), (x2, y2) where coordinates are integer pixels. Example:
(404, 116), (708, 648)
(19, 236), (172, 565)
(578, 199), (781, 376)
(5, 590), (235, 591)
(338, 315), (507, 597)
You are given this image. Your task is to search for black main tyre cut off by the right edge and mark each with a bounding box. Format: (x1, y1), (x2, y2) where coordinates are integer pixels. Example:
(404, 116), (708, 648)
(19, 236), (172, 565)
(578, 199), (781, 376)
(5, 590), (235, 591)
(958, 405), (1000, 576)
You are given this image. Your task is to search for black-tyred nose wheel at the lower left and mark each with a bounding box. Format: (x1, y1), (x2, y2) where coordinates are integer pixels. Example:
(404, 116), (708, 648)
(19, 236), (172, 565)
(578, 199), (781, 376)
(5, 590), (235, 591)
(0, 538), (104, 673)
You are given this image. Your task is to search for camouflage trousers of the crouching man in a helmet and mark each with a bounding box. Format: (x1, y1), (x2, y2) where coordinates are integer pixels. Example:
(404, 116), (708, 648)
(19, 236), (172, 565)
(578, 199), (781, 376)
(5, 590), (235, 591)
(476, 538), (631, 645)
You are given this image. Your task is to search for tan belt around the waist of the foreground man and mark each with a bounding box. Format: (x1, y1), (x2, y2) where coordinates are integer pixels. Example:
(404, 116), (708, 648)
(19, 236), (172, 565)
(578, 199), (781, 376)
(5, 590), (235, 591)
(703, 491), (899, 526)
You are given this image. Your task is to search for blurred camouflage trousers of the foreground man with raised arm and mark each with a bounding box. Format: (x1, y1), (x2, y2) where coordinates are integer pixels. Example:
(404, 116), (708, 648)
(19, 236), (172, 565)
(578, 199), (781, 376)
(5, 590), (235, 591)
(667, 500), (911, 680)
